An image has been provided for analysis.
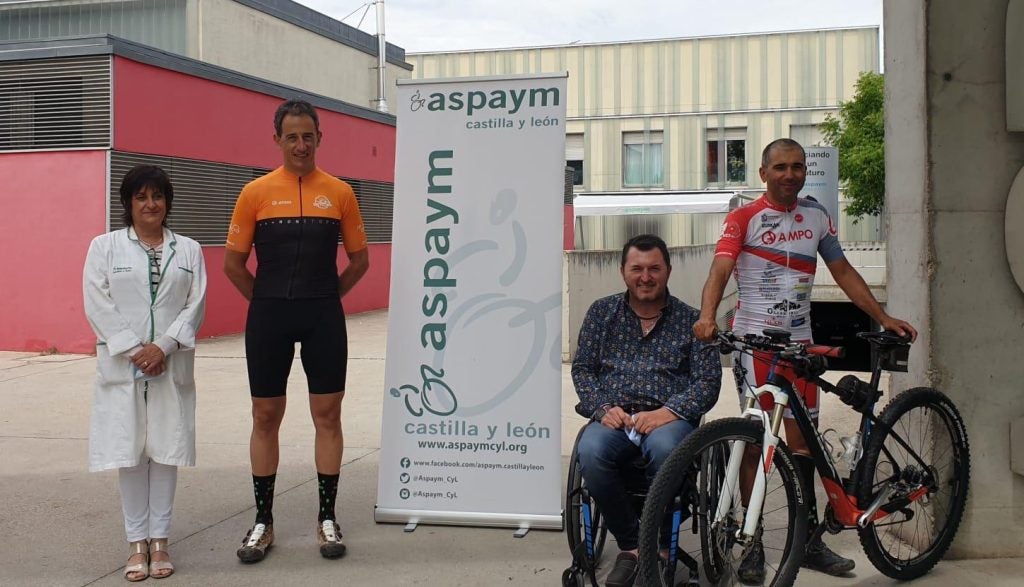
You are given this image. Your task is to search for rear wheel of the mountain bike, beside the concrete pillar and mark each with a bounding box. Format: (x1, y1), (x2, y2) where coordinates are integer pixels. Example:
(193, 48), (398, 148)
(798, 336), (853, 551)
(856, 387), (971, 581)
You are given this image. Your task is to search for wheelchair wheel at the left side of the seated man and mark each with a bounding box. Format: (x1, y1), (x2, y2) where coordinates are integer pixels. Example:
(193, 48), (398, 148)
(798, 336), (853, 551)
(562, 426), (608, 587)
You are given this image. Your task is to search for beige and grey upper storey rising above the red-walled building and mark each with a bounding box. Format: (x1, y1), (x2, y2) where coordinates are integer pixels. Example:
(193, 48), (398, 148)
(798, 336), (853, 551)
(0, 0), (412, 108)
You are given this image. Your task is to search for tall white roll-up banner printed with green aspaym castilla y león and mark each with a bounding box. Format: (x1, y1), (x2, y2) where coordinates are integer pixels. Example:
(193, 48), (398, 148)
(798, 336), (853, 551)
(374, 74), (566, 529)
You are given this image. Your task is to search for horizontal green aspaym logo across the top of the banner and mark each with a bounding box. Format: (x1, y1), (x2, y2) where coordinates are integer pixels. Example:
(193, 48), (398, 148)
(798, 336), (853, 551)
(409, 88), (561, 116)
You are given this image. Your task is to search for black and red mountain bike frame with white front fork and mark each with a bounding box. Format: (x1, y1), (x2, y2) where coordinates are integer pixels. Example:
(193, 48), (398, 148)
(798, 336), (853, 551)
(714, 349), (928, 540)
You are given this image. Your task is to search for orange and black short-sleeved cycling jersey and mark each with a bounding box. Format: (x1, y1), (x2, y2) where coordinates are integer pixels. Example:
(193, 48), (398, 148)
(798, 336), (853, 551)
(225, 167), (367, 299)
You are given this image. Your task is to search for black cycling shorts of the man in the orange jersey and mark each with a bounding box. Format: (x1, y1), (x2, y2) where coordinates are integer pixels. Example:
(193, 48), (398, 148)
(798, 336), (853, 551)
(246, 297), (348, 397)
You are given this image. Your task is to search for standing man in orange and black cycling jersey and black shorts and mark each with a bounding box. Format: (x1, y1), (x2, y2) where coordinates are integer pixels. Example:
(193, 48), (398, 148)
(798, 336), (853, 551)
(224, 100), (370, 562)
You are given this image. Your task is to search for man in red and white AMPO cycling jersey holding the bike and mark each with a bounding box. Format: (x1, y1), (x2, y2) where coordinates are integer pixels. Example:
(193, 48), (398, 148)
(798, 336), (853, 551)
(693, 138), (918, 584)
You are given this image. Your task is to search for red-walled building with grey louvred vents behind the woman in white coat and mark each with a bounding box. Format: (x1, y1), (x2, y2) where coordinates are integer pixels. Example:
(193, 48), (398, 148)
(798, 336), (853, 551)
(0, 0), (410, 352)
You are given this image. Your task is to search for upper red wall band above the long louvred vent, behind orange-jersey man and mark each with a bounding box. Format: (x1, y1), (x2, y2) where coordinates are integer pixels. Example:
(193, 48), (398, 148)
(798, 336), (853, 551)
(114, 57), (394, 181)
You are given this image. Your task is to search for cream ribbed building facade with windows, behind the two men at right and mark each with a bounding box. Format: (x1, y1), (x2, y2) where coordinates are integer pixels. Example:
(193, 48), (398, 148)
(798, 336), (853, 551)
(408, 28), (880, 249)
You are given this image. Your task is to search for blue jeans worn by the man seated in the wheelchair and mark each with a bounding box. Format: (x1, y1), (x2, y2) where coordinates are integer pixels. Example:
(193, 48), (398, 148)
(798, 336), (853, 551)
(577, 420), (694, 550)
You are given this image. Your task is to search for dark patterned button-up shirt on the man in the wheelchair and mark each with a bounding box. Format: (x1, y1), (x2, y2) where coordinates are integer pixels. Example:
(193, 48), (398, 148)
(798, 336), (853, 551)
(572, 292), (722, 424)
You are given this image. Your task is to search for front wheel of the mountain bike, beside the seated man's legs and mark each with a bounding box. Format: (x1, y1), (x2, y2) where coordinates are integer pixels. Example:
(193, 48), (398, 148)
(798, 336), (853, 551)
(640, 418), (807, 586)
